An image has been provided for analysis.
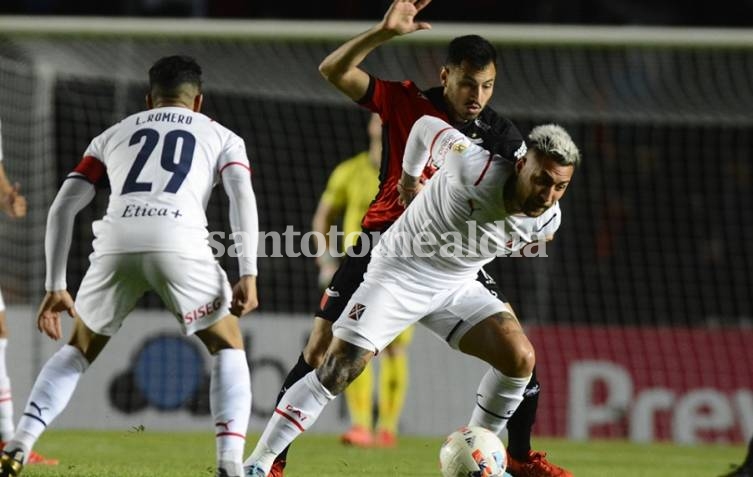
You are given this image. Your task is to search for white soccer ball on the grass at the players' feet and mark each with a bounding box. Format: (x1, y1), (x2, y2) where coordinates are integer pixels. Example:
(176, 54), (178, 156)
(439, 426), (507, 477)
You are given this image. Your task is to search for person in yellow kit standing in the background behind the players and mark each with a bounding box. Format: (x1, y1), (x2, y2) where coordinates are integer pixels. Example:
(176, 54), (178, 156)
(312, 114), (413, 447)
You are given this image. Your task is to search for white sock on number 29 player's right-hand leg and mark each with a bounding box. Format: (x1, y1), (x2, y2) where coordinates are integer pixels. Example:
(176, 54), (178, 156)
(209, 349), (251, 466)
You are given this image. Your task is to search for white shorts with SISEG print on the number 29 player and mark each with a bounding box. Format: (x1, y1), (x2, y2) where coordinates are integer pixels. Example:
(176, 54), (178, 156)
(75, 252), (232, 336)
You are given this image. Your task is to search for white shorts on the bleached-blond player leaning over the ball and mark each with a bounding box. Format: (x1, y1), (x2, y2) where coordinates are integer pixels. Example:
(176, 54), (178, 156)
(332, 270), (512, 352)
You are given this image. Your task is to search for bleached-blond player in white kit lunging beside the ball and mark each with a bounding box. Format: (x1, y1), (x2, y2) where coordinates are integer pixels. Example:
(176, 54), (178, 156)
(246, 116), (580, 477)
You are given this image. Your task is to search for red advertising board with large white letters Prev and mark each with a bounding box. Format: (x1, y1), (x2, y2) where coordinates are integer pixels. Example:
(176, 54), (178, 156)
(527, 326), (753, 443)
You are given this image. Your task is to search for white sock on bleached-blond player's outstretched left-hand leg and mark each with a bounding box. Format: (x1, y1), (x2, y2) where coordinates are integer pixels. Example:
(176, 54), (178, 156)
(244, 371), (335, 473)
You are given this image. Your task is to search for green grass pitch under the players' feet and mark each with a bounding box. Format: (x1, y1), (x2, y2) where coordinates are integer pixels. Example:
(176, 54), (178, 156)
(17, 430), (745, 477)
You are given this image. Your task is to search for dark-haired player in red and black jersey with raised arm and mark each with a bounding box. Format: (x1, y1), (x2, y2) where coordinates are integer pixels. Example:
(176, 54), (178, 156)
(246, 0), (571, 477)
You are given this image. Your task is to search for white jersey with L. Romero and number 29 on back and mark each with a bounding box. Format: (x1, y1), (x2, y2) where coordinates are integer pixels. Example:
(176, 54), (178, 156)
(79, 107), (250, 255)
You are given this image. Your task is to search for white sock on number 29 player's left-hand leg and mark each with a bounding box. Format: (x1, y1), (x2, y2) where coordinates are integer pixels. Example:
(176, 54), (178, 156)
(6, 345), (89, 457)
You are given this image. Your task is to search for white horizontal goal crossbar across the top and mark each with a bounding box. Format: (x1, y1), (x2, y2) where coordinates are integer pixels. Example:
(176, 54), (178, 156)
(0, 16), (753, 48)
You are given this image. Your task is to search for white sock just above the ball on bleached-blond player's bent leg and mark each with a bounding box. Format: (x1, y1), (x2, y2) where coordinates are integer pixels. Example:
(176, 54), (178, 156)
(468, 368), (531, 434)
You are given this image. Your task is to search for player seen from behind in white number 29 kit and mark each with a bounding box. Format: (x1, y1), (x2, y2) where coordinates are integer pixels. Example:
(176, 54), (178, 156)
(0, 56), (258, 477)
